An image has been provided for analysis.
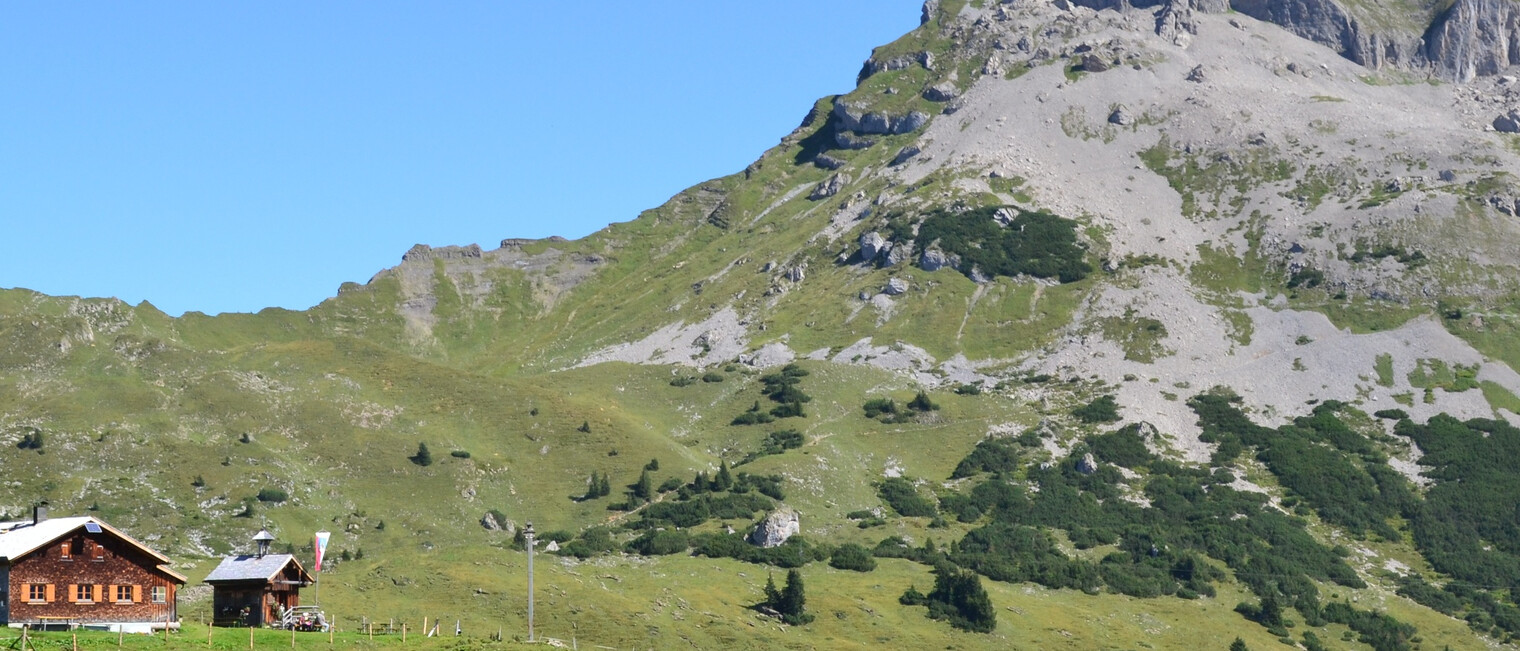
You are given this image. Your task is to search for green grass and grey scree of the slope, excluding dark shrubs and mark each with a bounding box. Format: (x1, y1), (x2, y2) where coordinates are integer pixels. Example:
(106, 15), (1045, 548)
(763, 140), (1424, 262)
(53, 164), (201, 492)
(0, 2), (1520, 648)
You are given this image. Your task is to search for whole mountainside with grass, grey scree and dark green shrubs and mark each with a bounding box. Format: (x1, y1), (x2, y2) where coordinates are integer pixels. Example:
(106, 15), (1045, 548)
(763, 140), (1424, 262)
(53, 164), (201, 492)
(0, 0), (1520, 649)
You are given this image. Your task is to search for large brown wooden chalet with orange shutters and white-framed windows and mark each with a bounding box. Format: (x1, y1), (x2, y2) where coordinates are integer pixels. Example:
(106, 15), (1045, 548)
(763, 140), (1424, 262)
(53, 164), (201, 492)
(0, 503), (185, 633)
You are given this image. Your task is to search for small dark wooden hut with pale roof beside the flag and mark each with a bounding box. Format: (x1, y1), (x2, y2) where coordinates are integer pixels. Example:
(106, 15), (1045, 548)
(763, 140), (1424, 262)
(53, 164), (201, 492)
(205, 531), (313, 627)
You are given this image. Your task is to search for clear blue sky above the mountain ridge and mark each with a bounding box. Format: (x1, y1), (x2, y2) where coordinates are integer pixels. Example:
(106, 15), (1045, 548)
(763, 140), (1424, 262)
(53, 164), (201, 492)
(0, 0), (920, 315)
